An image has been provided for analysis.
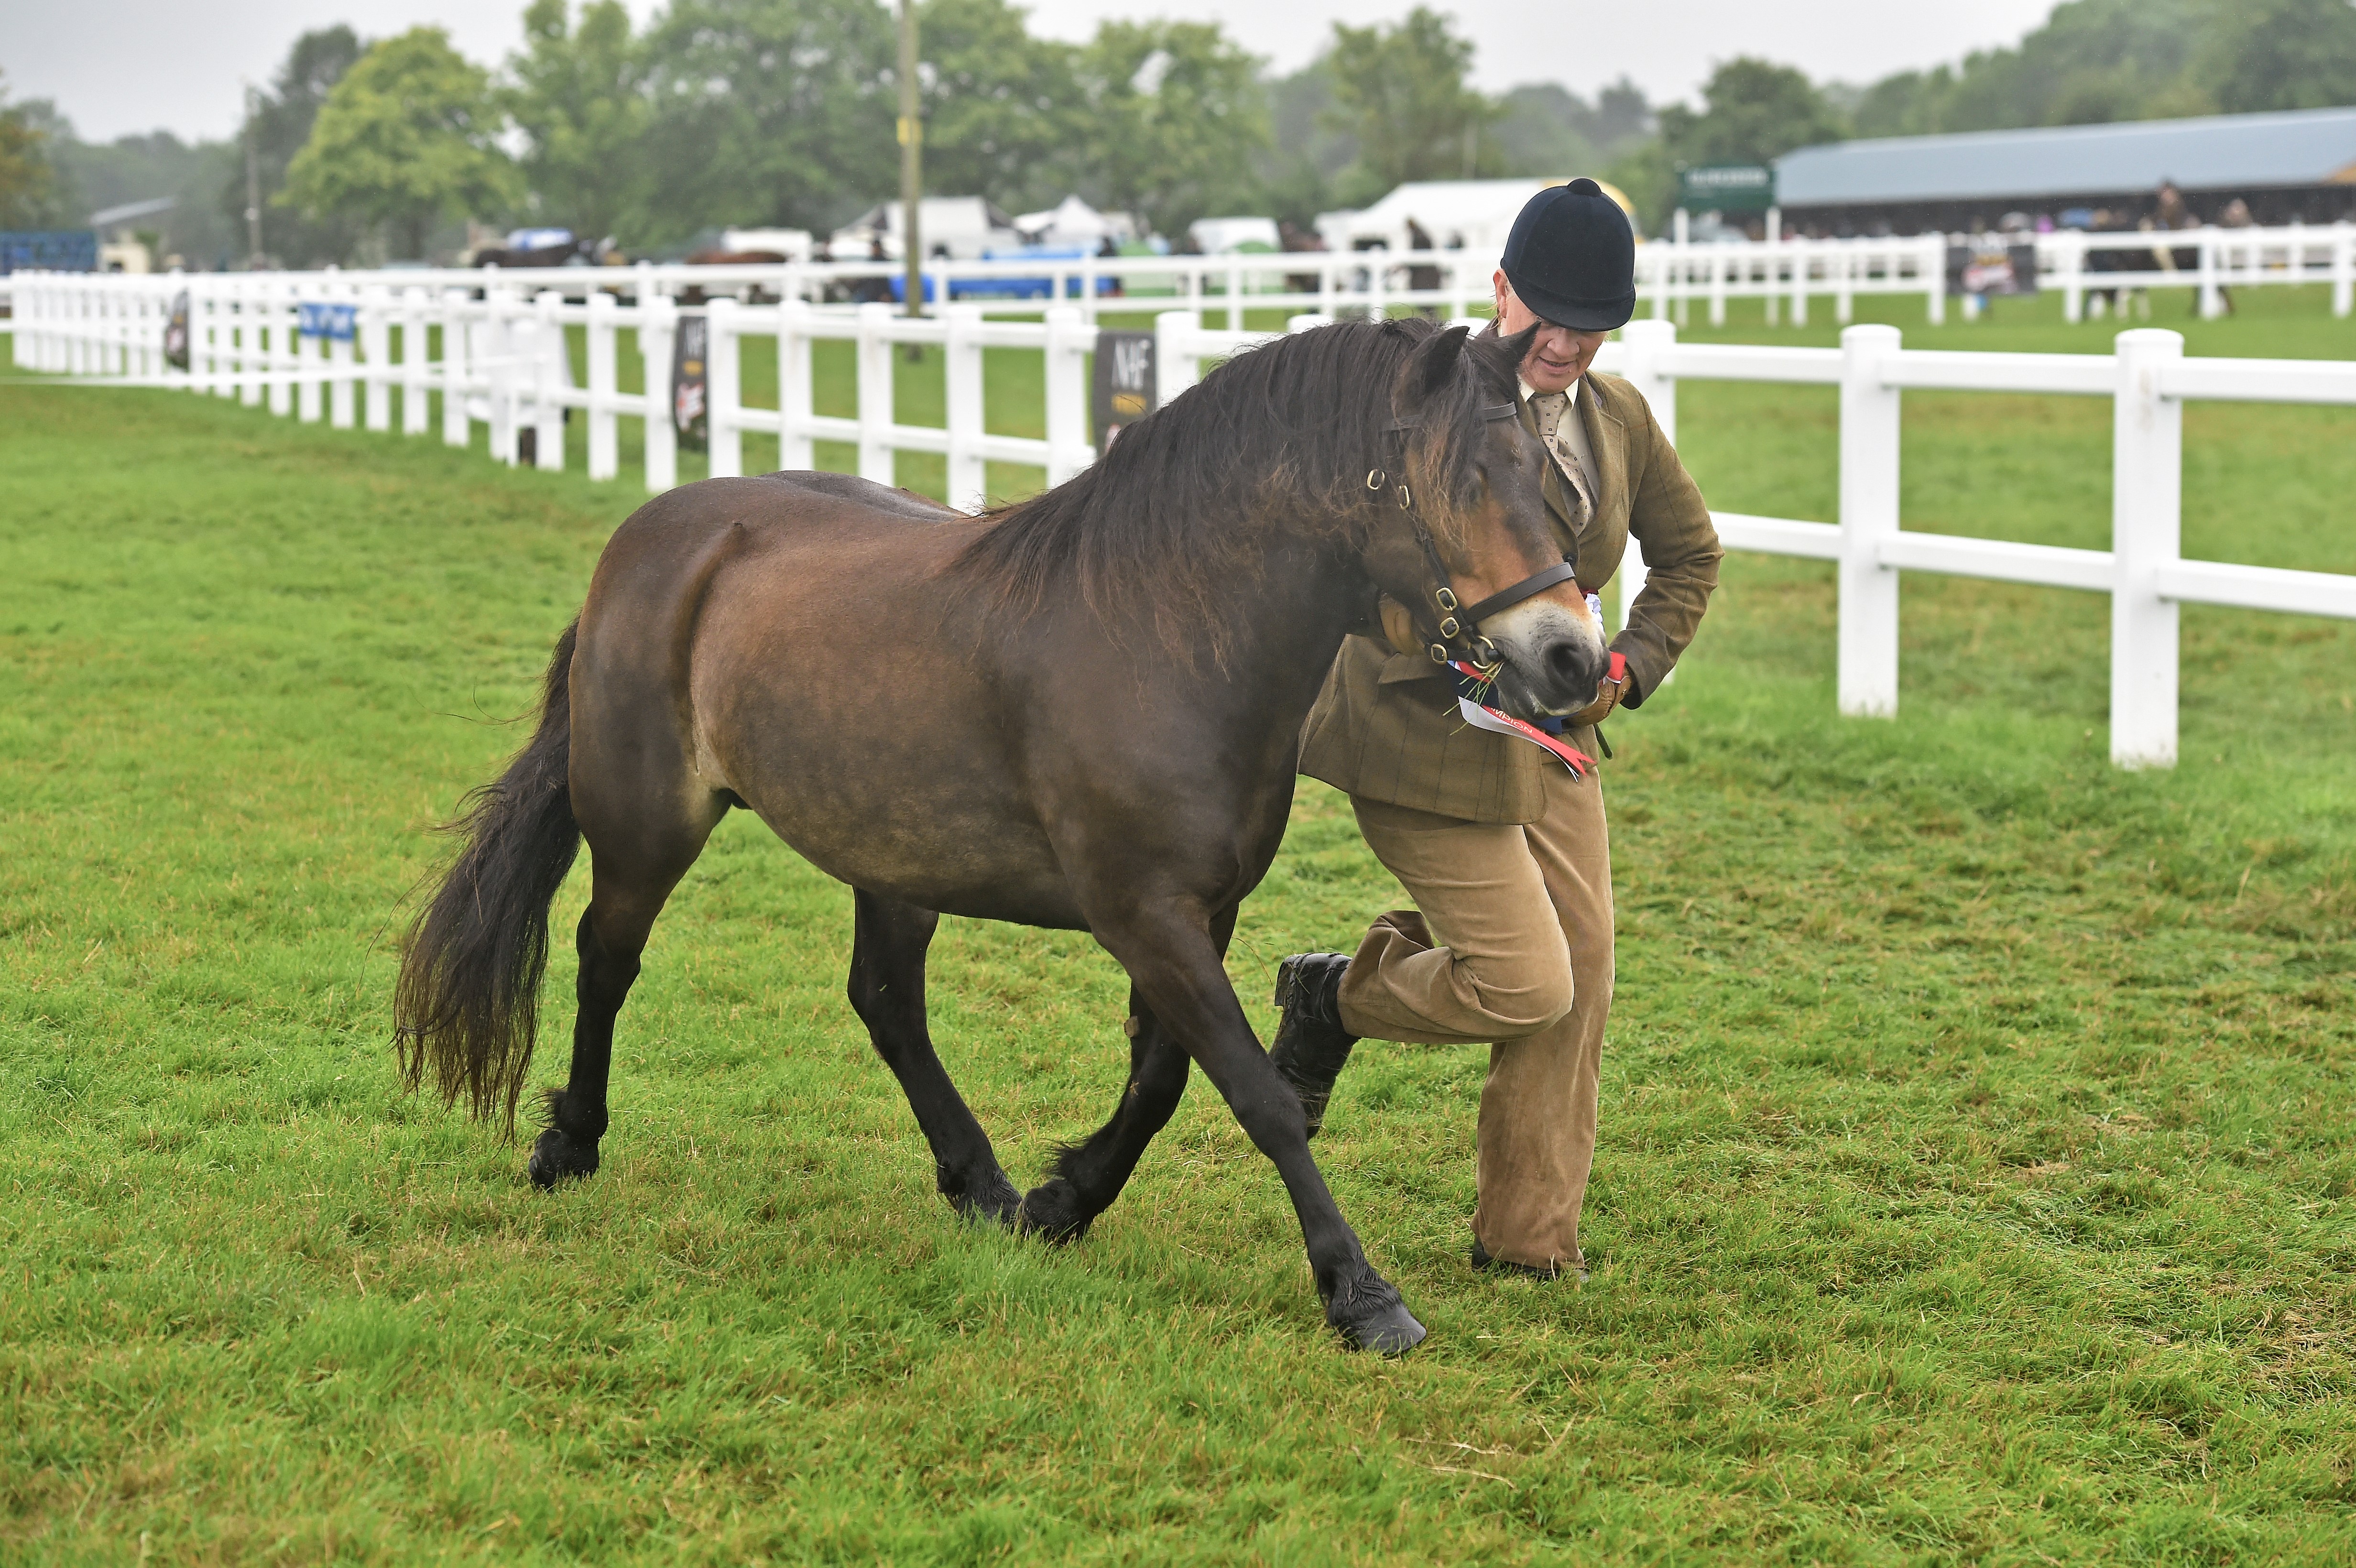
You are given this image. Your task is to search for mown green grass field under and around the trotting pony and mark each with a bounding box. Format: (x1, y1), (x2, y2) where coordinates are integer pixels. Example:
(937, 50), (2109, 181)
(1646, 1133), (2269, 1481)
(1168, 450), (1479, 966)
(0, 292), (2356, 1563)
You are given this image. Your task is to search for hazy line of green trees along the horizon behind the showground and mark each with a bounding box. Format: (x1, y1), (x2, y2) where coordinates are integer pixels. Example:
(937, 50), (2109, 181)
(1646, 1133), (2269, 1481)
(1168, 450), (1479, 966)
(0, 0), (2356, 266)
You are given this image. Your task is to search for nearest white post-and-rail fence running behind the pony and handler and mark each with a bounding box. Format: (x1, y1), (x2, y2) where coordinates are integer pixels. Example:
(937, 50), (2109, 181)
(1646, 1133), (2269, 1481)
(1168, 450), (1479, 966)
(12, 273), (2356, 768)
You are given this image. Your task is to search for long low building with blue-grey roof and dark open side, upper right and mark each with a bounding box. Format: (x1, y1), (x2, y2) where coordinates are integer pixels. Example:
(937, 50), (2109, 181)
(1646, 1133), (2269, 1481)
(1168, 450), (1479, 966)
(1777, 109), (2356, 233)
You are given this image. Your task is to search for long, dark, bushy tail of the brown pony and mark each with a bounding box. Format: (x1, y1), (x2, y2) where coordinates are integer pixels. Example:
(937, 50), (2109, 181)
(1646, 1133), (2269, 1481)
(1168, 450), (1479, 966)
(393, 621), (582, 1135)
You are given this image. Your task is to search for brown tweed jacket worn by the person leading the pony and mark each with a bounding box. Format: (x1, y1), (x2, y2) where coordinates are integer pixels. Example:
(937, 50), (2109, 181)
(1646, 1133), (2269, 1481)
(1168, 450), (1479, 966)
(1300, 362), (1722, 822)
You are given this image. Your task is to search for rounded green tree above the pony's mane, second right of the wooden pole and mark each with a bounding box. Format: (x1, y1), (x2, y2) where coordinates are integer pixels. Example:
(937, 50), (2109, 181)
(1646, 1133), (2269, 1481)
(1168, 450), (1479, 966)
(1079, 21), (1270, 233)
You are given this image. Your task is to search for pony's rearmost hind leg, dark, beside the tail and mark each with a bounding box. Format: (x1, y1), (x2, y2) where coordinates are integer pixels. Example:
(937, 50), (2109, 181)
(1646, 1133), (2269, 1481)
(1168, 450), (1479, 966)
(530, 798), (728, 1187)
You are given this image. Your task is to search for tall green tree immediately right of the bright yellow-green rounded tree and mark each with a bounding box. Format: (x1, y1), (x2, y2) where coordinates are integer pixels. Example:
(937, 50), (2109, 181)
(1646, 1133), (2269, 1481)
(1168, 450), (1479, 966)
(507, 0), (655, 240)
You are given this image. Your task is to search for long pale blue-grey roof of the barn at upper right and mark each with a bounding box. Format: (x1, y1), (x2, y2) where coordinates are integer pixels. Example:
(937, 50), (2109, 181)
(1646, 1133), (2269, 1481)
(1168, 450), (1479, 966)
(1777, 109), (2356, 207)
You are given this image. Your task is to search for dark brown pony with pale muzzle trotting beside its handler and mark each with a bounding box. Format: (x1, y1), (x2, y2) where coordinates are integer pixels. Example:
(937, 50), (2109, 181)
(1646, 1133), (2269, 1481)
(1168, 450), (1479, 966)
(396, 320), (1604, 1354)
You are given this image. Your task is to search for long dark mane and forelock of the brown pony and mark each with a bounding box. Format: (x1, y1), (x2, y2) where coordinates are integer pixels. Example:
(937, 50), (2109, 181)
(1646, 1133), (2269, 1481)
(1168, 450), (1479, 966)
(954, 318), (1527, 650)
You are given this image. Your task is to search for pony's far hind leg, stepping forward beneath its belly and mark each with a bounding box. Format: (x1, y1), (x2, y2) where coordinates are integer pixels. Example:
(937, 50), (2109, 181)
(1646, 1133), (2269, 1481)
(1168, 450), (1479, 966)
(851, 890), (1023, 1224)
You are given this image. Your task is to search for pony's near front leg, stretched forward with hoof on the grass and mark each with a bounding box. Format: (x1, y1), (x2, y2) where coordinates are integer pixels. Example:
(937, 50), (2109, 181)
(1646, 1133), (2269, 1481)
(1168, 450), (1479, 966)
(1091, 904), (1423, 1356)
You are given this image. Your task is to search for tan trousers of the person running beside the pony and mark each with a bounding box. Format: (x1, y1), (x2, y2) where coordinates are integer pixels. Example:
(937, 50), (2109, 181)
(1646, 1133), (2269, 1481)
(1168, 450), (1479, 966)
(1341, 739), (1612, 1267)
